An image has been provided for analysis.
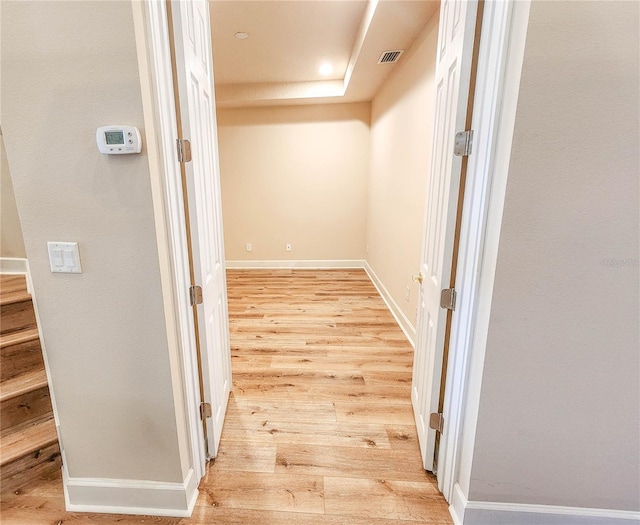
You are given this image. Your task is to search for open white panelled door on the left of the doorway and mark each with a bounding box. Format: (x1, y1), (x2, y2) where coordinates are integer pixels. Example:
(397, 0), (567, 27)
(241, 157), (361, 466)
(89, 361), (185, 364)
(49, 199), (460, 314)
(171, 0), (231, 457)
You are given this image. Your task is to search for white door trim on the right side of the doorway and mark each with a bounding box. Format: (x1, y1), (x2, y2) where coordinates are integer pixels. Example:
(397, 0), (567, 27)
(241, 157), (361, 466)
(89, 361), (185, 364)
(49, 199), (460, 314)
(438, 0), (530, 510)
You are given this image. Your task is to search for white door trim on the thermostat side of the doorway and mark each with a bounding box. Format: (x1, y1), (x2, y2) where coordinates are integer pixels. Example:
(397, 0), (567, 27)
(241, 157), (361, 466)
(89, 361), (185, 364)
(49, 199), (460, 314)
(132, 0), (206, 486)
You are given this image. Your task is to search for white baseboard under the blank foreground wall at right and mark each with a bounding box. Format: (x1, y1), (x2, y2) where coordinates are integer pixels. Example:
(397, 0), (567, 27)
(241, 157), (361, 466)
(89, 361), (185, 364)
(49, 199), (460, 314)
(449, 484), (640, 525)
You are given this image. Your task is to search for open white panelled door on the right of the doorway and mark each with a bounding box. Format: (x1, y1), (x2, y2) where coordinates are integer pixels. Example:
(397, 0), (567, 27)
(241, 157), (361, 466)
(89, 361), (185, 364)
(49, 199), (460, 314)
(411, 0), (478, 471)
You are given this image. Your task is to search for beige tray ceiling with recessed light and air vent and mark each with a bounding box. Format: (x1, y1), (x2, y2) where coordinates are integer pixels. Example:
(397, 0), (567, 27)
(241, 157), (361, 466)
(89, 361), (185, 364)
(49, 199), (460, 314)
(210, 0), (440, 107)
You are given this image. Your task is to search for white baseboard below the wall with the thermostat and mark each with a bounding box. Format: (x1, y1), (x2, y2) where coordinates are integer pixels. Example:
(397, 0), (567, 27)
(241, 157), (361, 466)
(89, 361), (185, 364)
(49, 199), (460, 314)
(62, 465), (198, 518)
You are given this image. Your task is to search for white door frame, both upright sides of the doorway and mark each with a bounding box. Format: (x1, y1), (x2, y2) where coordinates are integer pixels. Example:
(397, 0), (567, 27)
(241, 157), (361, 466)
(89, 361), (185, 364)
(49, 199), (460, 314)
(132, 0), (531, 508)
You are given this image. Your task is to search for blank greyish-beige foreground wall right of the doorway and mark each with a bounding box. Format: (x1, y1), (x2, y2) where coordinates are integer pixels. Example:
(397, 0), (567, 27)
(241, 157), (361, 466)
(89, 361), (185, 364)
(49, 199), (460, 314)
(469, 2), (640, 511)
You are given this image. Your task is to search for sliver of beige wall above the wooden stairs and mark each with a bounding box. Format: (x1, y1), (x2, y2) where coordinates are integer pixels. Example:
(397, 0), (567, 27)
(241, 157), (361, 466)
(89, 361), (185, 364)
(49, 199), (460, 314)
(0, 135), (27, 258)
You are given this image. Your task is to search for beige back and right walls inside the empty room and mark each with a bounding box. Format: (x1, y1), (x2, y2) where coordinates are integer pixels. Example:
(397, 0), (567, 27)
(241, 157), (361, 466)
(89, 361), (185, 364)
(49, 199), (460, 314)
(218, 13), (438, 325)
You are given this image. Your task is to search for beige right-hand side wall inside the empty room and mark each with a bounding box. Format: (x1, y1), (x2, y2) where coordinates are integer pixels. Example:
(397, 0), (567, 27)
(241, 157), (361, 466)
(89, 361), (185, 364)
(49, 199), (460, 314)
(367, 12), (439, 327)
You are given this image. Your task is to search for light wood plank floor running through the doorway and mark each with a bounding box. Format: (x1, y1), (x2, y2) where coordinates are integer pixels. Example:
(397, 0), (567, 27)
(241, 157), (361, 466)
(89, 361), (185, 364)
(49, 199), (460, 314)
(1, 270), (451, 525)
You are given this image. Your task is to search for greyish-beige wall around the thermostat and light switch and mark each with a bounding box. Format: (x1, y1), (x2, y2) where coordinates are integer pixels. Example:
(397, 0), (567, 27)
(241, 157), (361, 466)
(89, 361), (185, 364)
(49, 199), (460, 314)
(2, 1), (183, 483)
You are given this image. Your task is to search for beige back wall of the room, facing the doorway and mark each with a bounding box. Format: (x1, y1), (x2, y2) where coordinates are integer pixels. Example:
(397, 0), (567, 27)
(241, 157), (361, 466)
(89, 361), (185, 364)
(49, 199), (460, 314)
(218, 103), (370, 260)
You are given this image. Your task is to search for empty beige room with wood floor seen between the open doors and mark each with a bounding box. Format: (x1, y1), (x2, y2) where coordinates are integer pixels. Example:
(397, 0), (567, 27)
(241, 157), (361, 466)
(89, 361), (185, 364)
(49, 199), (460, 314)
(209, 2), (450, 523)
